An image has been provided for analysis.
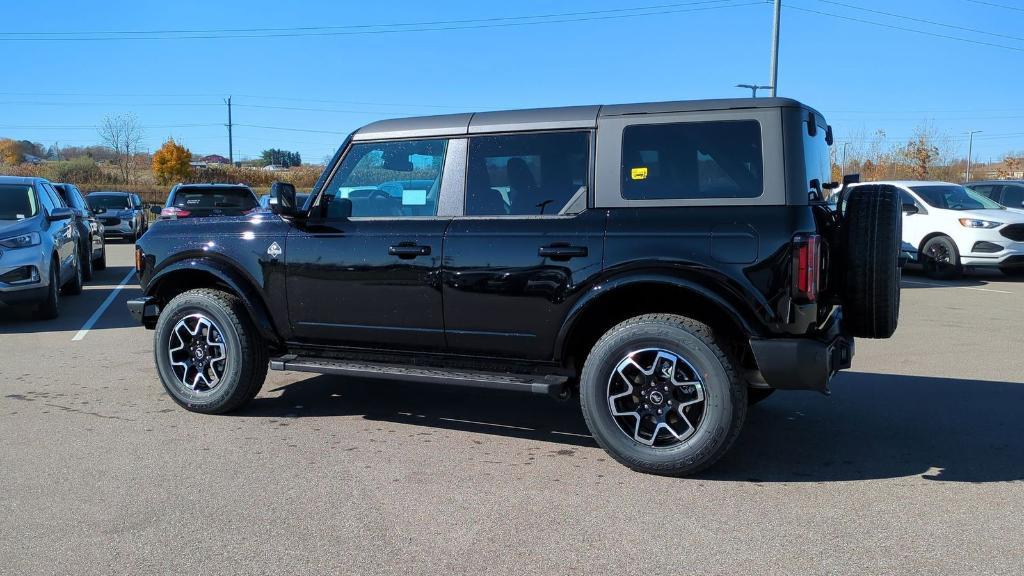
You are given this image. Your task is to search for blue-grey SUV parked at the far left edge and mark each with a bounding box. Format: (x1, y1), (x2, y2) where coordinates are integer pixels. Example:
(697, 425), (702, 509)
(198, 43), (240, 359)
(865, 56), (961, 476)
(0, 176), (82, 319)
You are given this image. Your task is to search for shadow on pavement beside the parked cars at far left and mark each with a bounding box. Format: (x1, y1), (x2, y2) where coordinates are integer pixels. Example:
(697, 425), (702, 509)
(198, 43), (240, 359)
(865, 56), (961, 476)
(0, 266), (138, 335)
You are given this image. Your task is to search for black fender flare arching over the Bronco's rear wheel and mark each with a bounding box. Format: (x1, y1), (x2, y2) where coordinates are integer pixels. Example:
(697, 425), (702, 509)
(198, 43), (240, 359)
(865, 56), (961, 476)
(555, 272), (762, 360)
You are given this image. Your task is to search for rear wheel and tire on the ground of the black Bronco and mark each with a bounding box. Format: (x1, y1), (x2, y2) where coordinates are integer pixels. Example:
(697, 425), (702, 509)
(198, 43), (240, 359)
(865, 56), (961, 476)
(580, 314), (748, 476)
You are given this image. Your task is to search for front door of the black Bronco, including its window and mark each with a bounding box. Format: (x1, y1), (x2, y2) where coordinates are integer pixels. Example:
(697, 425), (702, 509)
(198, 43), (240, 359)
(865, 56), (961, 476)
(284, 139), (451, 351)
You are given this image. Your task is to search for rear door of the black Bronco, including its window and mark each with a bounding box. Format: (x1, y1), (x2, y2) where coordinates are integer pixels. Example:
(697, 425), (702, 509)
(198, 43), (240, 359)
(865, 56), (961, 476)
(443, 130), (605, 360)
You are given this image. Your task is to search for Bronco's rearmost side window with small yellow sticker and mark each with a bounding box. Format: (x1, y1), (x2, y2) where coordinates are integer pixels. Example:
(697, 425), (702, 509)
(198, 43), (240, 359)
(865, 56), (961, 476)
(622, 120), (764, 200)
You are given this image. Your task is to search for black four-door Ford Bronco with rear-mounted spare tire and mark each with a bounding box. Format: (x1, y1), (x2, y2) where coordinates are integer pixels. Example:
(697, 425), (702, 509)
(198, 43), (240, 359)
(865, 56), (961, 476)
(128, 98), (901, 475)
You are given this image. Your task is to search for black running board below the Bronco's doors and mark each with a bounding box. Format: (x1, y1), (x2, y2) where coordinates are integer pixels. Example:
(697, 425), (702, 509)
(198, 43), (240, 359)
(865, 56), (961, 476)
(270, 355), (568, 399)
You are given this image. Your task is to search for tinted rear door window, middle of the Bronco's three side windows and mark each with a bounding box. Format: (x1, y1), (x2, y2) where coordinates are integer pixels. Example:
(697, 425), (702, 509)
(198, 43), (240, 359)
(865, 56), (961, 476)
(466, 132), (590, 216)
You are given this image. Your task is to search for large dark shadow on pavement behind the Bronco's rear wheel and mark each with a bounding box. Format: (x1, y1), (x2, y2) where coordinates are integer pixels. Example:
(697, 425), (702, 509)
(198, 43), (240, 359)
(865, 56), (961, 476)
(701, 372), (1024, 483)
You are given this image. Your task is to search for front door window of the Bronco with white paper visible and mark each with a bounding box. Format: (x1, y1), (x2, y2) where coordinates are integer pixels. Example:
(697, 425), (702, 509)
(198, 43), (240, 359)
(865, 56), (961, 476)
(321, 139), (447, 218)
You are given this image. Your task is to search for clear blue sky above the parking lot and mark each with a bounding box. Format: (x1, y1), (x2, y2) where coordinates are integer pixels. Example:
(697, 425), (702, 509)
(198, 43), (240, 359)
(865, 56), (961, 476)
(0, 0), (1024, 162)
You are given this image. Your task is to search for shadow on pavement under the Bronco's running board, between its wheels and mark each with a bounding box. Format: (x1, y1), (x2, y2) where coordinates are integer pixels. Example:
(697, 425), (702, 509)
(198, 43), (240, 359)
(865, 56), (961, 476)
(243, 376), (597, 446)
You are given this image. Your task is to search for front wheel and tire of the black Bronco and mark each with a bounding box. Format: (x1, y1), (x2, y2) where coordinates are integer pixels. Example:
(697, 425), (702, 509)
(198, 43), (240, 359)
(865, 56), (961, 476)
(154, 288), (268, 414)
